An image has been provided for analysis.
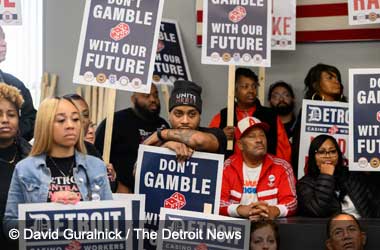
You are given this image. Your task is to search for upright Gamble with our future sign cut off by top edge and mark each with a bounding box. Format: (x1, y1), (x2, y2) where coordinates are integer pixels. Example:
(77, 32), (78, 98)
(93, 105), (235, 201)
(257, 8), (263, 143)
(202, 0), (272, 67)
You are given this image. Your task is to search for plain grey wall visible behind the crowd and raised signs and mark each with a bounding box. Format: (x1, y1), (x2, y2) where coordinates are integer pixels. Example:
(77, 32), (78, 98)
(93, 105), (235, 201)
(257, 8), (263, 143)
(44, 0), (380, 125)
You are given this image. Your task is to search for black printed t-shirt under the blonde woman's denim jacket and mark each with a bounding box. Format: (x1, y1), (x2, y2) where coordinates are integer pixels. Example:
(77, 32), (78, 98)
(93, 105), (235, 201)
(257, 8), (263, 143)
(46, 156), (83, 202)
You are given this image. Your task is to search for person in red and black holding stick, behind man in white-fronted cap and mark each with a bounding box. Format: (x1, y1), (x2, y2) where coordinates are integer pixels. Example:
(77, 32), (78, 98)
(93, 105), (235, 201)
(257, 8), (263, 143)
(209, 68), (291, 162)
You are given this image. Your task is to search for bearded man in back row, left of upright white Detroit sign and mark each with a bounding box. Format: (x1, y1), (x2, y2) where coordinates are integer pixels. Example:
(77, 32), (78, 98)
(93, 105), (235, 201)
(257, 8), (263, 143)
(268, 81), (296, 141)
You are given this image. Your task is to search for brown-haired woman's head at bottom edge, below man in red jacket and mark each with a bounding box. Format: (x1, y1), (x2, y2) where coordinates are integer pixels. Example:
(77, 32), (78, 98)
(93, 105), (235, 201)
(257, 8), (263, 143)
(249, 220), (280, 250)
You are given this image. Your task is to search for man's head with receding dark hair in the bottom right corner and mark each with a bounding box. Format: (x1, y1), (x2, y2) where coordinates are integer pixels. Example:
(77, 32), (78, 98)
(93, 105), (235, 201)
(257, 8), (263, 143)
(326, 213), (367, 250)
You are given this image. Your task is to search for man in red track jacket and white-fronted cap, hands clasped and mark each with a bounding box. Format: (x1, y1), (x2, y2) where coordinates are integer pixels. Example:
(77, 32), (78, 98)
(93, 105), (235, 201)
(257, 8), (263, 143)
(220, 117), (297, 220)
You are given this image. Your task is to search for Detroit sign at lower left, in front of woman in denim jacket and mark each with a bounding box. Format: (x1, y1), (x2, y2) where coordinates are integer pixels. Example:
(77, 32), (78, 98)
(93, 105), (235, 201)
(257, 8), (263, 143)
(19, 201), (132, 249)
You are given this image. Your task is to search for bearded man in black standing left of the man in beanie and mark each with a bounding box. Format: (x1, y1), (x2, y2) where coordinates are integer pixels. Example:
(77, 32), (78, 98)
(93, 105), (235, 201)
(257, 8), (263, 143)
(95, 84), (169, 193)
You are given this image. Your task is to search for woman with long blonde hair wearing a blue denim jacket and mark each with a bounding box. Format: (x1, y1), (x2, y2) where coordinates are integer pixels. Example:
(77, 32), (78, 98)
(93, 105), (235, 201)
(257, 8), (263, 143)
(4, 97), (112, 230)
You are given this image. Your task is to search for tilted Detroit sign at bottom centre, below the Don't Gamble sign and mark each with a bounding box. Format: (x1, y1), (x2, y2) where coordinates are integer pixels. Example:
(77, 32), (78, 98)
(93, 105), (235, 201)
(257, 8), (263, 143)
(157, 208), (250, 250)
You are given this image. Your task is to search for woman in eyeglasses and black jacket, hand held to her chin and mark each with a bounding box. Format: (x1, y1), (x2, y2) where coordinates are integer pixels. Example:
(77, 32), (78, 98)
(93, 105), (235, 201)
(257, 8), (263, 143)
(297, 134), (380, 218)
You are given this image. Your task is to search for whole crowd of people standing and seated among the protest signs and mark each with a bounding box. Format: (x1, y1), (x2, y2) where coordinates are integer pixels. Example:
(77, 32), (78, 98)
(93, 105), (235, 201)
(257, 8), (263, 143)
(0, 24), (380, 249)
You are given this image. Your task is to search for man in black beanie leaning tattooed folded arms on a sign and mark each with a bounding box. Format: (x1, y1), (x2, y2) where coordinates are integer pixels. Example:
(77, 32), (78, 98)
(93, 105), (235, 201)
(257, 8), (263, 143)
(144, 80), (227, 162)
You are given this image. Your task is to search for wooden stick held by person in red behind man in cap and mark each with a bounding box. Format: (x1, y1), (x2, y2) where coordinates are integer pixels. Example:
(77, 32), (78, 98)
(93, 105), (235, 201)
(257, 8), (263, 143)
(227, 65), (235, 150)
